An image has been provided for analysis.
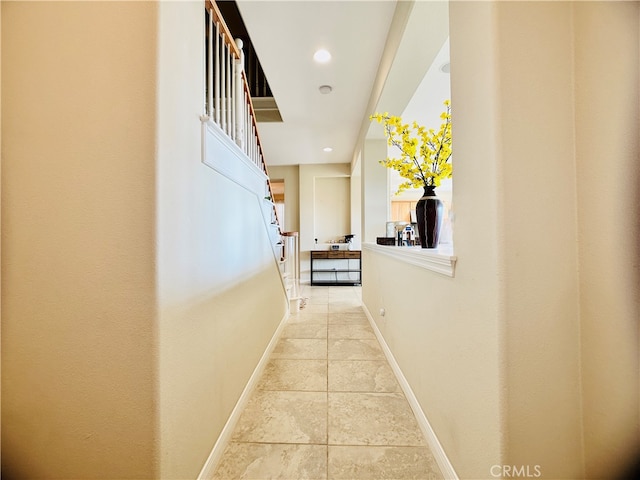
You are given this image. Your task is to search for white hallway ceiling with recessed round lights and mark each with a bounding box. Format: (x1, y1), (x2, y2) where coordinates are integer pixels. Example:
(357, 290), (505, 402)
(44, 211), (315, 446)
(237, 0), (448, 169)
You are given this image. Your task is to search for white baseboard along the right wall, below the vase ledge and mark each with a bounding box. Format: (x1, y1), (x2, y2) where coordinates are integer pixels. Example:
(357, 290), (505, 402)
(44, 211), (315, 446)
(362, 304), (459, 480)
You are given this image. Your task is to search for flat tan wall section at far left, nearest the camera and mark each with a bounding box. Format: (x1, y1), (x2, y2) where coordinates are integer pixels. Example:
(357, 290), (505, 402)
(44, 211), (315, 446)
(1, 2), (158, 479)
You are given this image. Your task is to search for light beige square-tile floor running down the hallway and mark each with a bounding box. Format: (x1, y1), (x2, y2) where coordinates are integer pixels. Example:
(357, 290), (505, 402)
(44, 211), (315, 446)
(214, 285), (442, 480)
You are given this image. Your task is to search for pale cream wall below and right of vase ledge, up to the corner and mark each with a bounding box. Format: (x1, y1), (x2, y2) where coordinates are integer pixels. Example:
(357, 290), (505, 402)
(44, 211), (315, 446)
(363, 2), (505, 479)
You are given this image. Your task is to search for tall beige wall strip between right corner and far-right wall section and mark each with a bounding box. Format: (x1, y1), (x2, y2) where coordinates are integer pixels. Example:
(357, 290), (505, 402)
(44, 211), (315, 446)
(500, 2), (584, 478)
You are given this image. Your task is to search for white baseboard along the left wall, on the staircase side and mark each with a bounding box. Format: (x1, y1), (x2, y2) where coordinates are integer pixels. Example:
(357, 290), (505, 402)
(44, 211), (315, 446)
(197, 310), (289, 480)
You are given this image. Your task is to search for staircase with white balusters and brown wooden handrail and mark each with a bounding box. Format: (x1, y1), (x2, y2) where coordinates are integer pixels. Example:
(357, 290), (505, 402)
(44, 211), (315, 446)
(201, 0), (299, 310)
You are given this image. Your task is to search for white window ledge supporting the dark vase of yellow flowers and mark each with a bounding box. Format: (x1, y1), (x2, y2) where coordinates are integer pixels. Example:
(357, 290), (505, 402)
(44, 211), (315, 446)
(362, 243), (458, 277)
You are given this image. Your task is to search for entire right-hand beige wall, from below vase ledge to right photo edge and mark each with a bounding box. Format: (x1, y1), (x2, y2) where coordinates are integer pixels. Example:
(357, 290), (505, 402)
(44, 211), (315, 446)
(363, 2), (640, 479)
